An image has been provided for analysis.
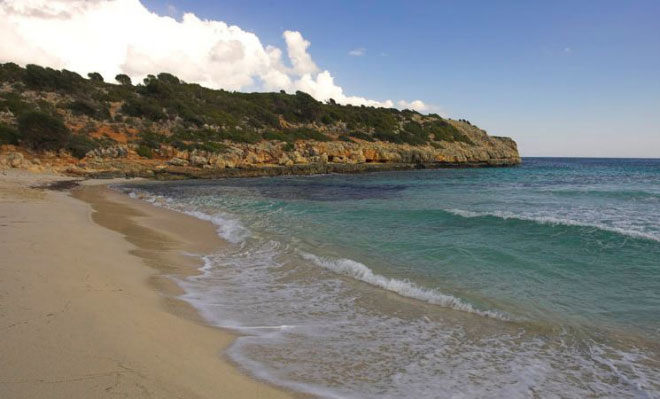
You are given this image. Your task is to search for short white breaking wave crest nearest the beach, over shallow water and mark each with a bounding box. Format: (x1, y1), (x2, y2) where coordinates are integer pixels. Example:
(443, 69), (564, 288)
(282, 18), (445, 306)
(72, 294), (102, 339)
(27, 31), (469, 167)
(299, 251), (510, 321)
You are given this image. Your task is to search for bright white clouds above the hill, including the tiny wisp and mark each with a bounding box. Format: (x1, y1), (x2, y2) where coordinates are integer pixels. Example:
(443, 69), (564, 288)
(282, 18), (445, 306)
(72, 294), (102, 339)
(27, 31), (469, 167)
(0, 0), (429, 111)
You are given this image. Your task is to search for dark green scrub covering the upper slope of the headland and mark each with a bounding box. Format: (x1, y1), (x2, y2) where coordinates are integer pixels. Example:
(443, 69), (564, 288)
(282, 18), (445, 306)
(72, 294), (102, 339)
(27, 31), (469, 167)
(0, 63), (470, 154)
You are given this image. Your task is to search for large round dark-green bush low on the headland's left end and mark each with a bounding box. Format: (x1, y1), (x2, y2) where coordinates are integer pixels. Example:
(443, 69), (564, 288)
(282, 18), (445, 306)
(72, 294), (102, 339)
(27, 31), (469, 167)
(18, 111), (71, 150)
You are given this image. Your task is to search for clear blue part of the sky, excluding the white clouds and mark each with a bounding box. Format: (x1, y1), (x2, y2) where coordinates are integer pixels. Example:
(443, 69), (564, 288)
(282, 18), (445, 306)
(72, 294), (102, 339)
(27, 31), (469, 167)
(144, 0), (660, 157)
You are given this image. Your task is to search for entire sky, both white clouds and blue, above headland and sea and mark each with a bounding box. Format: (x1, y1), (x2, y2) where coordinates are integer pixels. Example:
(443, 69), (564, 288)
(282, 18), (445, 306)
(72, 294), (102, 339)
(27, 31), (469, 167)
(0, 0), (660, 158)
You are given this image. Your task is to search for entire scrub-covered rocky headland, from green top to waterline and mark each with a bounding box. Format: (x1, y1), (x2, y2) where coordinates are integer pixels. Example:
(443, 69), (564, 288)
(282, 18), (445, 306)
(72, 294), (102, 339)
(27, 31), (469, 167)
(0, 63), (520, 177)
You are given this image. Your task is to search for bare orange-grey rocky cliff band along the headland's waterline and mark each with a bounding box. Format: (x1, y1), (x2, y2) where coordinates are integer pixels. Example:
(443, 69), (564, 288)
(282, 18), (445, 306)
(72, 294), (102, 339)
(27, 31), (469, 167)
(0, 122), (520, 178)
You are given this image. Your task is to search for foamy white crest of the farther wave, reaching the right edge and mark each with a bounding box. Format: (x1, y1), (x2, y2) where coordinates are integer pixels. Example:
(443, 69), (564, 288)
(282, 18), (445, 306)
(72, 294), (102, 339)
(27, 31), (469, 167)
(445, 209), (660, 242)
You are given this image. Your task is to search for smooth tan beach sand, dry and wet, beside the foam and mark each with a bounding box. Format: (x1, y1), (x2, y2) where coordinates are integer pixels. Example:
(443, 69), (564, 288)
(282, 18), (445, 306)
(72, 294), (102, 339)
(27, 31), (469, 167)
(0, 171), (291, 398)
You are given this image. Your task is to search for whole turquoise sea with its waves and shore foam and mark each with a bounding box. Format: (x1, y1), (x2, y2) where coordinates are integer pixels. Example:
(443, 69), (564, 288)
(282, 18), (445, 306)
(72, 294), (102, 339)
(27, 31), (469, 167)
(120, 158), (660, 398)
